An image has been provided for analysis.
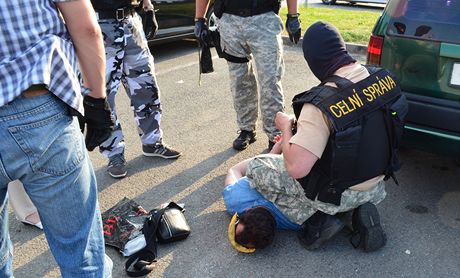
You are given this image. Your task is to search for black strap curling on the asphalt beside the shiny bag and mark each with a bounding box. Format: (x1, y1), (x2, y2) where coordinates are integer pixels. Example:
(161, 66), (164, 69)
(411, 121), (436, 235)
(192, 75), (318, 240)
(125, 205), (169, 277)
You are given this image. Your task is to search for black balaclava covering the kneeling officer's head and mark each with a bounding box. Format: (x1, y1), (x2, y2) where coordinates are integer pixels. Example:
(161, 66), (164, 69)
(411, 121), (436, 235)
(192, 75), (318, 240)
(302, 21), (356, 82)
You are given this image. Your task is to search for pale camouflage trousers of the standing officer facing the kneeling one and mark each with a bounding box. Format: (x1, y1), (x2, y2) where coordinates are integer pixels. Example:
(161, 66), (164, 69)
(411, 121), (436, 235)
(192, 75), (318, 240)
(218, 12), (284, 140)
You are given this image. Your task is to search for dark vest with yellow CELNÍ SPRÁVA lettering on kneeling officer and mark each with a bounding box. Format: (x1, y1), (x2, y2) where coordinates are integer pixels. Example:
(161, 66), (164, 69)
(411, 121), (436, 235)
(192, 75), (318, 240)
(292, 64), (408, 205)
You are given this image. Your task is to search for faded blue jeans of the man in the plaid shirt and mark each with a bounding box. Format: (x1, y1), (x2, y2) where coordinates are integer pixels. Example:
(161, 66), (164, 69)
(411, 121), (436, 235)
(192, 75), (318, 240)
(0, 93), (112, 277)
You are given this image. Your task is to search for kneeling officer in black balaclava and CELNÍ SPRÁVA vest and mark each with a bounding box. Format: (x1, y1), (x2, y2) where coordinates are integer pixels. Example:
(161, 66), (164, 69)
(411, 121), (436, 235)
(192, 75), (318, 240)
(268, 21), (407, 252)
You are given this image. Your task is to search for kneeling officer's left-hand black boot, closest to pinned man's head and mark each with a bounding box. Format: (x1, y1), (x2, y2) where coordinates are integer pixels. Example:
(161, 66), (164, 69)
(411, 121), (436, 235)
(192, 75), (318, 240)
(297, 211), (345, 251)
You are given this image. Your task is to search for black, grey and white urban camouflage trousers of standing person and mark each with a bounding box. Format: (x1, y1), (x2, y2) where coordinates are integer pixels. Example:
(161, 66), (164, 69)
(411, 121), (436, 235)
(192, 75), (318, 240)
(99, 14), (162, 157)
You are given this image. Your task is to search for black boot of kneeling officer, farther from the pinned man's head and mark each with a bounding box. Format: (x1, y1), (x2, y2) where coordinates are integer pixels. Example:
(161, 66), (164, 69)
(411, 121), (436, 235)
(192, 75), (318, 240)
(357, 203), (387, 252)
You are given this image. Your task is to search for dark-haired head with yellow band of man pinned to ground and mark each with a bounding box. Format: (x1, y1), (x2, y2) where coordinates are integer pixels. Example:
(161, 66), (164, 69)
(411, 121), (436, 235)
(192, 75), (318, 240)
(228, 206), (276, 253)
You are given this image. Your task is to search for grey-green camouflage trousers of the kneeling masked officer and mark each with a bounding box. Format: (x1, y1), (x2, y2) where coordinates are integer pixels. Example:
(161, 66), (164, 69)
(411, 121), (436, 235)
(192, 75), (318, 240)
(246, 154), (386, 224)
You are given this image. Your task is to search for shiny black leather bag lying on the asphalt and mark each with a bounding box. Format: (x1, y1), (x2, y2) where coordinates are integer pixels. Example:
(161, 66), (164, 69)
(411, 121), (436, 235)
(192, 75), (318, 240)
(152, 202), (190, 243)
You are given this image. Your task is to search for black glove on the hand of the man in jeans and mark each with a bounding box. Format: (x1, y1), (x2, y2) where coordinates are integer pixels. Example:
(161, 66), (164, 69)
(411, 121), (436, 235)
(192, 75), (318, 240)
(79, 96), (115, 151)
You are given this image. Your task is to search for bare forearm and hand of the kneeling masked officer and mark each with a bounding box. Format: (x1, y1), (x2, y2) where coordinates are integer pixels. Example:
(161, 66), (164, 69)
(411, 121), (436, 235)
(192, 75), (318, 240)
(275, 112), (318, 179)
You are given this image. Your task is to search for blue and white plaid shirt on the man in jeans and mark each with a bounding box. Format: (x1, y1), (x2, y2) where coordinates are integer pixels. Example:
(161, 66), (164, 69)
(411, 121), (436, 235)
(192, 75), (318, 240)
(0, 0), (83, 113)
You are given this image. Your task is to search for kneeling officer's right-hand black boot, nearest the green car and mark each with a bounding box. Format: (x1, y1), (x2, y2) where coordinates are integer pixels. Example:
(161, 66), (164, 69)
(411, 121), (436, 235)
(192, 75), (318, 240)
(350, 203), (387, 252)
